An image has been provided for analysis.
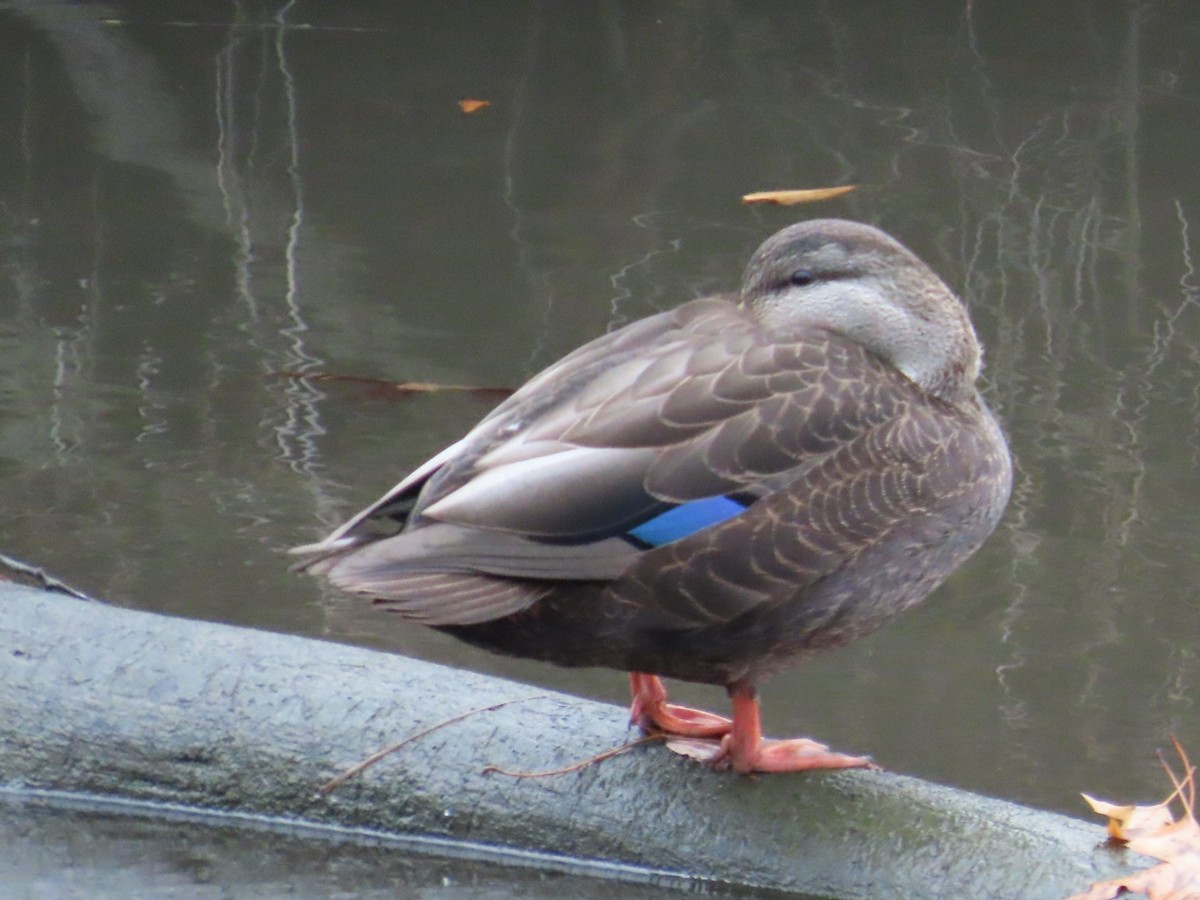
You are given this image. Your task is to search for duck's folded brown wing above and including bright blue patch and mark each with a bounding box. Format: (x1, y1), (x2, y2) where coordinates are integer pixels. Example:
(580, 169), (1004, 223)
(415, 314), (919, 545)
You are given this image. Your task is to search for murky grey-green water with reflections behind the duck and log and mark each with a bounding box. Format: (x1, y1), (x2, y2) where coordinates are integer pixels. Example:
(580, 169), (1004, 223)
(0, 0), (1200, 897)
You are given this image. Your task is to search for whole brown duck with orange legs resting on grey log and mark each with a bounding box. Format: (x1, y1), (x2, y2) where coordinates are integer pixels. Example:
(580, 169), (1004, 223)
(294, 218), (1012, 774)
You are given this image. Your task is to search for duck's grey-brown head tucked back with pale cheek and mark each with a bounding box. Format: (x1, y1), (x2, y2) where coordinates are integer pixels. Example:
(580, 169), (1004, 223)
(739, 218), (982, 401)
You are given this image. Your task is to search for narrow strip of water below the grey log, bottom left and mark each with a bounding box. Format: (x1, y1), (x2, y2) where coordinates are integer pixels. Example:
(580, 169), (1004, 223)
(0, 797), (751, 900)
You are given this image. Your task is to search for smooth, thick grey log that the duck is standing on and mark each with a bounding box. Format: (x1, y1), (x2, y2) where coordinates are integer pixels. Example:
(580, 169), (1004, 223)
(0, 583), (1141, 900)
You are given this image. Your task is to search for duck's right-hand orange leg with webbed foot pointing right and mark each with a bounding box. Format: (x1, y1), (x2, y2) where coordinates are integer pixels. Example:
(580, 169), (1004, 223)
(710, 682), (876, 774)
